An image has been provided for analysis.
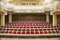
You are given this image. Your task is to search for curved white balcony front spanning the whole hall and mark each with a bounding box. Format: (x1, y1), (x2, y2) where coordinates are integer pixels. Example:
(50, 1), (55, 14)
(0, 1), (59, 12)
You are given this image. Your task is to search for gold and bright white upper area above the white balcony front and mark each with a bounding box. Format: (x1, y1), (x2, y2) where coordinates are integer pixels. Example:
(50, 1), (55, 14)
(2, 0), (53, 5)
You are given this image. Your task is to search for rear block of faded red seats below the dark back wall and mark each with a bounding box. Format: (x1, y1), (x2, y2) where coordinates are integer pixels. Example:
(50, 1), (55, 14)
(6, 21), (51, 28)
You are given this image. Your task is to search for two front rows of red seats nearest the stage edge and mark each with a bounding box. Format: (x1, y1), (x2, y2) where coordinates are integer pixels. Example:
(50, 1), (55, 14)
(0, 29), (59, 34)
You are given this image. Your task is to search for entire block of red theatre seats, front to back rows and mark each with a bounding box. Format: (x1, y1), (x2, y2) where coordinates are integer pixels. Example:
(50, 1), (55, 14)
(0, 21), (60, 34)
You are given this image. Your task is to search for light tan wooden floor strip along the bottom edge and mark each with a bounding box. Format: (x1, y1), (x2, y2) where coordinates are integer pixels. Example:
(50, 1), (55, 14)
(0, 38), (60, 40)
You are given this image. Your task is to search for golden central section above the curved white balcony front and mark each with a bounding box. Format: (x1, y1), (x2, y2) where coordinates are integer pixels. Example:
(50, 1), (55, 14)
(5, 0), (43, 5)
